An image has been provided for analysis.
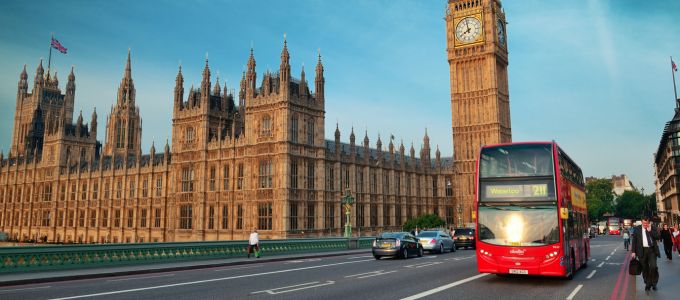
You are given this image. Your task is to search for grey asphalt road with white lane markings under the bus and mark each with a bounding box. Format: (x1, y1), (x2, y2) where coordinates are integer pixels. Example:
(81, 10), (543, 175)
(0, 236), (635, 300)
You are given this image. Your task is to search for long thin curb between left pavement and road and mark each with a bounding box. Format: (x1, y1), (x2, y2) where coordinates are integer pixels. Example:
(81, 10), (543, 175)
(0, 250), (370, 287)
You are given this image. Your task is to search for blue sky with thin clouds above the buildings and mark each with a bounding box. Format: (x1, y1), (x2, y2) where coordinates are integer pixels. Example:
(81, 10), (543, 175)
(0, 0), (680, 192)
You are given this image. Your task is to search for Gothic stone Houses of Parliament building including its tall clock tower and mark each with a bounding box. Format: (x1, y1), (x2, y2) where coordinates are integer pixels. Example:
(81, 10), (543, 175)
(0, 0), (510, 243)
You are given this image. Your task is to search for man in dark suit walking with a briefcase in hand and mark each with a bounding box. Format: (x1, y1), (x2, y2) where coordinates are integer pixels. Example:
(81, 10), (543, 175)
(631, 217), (659, 292)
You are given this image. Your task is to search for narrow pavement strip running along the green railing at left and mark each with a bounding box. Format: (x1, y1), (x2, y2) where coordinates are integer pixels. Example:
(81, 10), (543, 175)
(0, 249), (371, 287)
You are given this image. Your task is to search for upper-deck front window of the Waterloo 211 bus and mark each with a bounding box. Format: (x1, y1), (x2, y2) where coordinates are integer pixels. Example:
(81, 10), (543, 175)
(479, 144), (554, 178)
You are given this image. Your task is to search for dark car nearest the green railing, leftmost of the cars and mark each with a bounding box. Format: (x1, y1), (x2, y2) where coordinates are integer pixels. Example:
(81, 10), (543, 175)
(373, 232), (423, 259)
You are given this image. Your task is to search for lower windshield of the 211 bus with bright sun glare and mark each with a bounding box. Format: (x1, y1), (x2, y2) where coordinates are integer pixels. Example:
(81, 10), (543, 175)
(478, 203), (560, 246)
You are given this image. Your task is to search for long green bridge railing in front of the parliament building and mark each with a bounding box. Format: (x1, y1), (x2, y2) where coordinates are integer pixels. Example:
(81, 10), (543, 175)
(0, 237), (373, 274)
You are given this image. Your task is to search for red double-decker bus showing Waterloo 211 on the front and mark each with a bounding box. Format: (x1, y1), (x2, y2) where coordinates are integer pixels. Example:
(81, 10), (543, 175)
(476, 142), (590, 278)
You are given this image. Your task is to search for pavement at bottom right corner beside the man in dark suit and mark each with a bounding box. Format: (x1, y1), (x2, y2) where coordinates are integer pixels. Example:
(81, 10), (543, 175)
(635, 244), (680, 299)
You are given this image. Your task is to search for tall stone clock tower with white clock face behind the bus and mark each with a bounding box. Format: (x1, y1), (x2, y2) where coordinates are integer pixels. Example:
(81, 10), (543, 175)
(445, 0), (512, 225)
